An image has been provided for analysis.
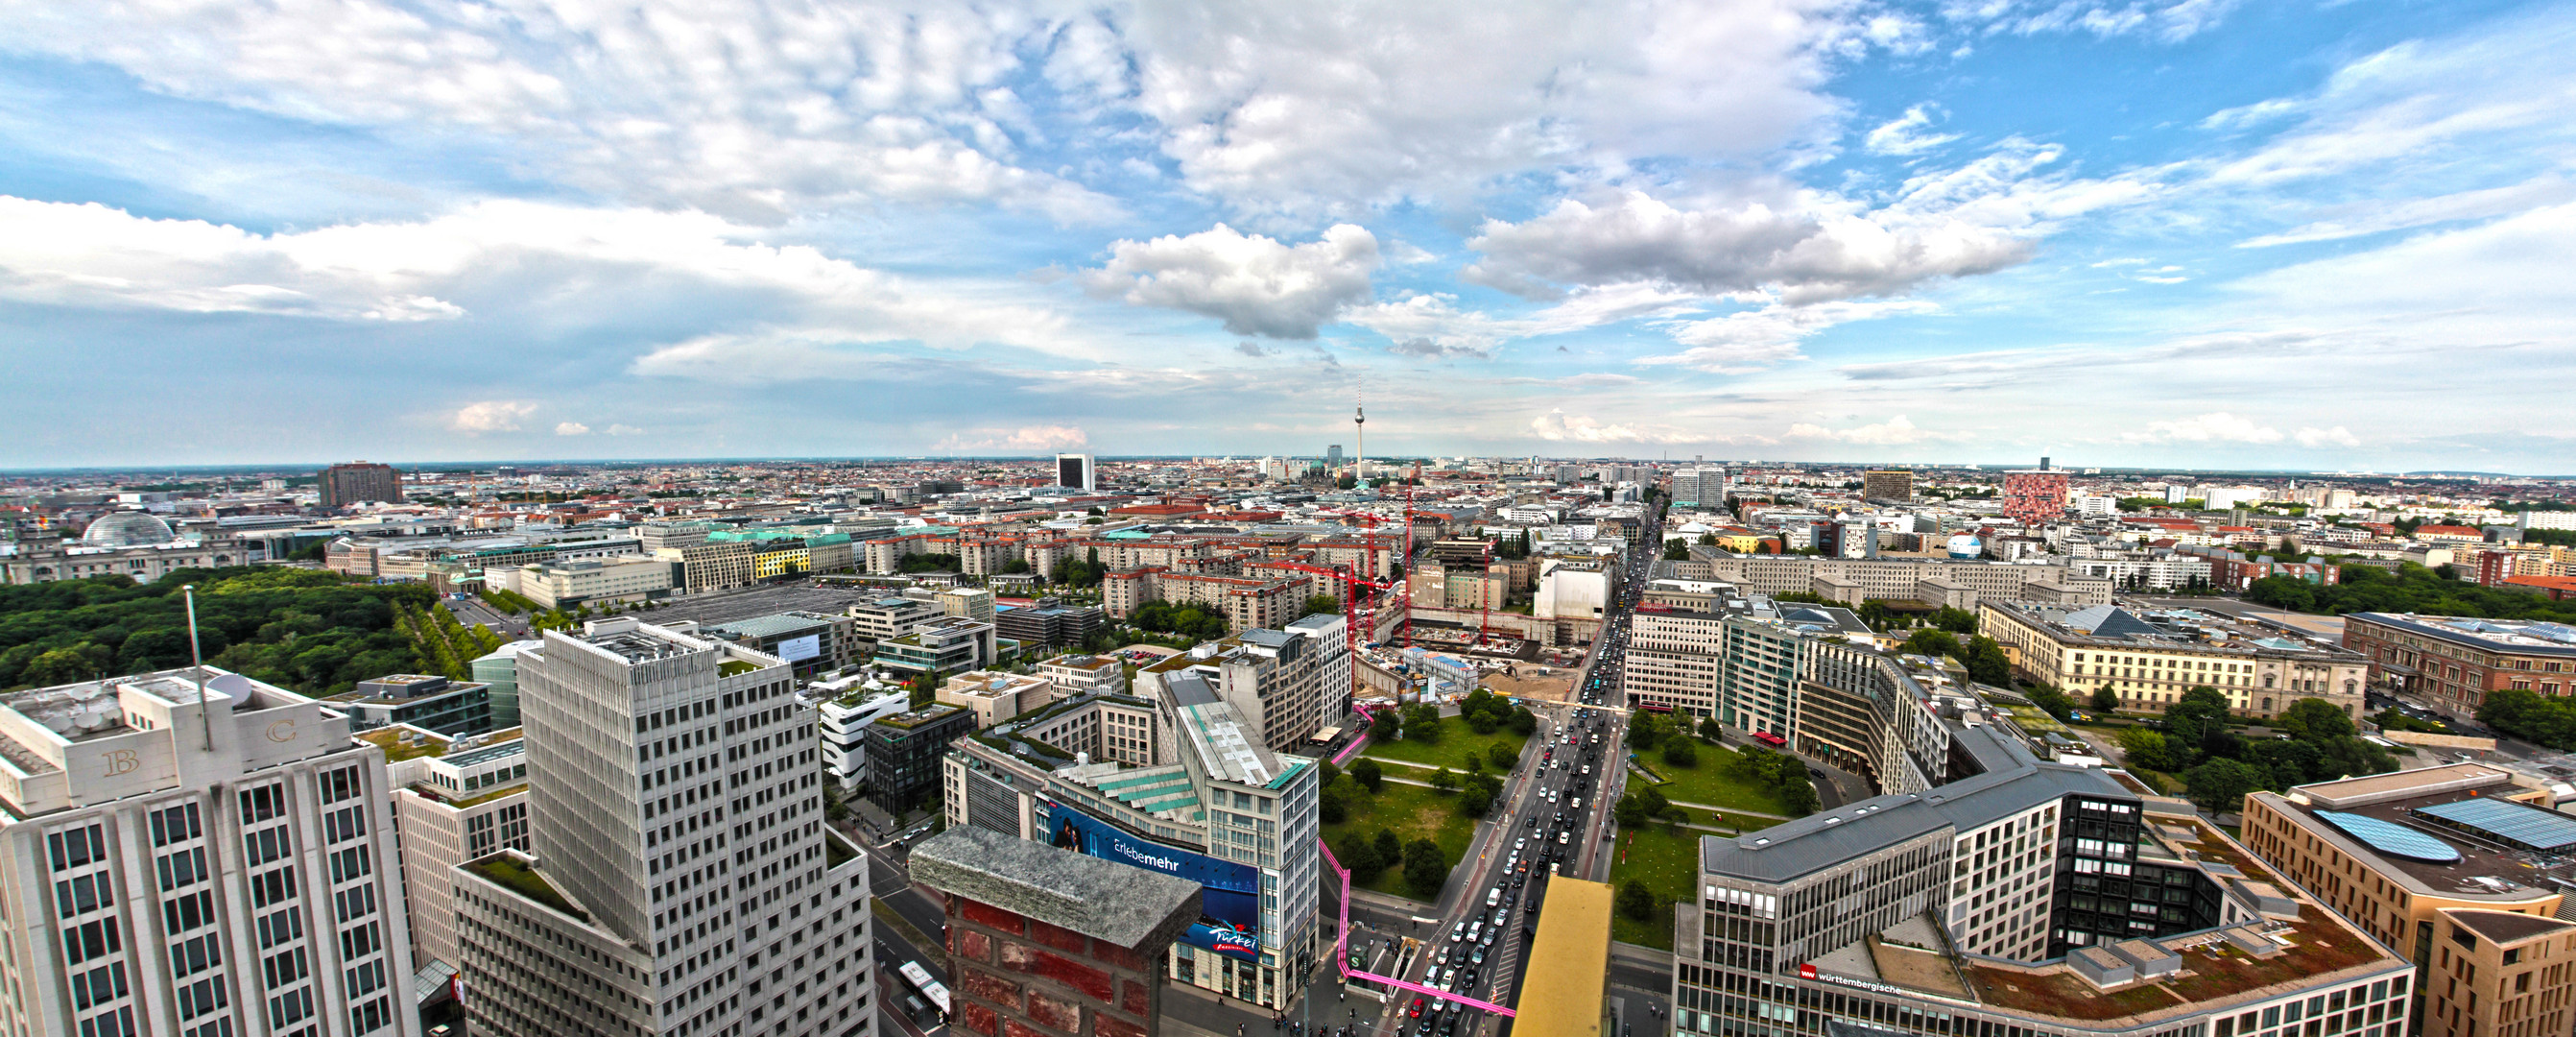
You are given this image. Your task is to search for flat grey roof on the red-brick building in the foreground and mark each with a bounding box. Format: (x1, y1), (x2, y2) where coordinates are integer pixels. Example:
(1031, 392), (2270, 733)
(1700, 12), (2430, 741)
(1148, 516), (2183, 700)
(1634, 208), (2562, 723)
(912, 826), (1201, 950)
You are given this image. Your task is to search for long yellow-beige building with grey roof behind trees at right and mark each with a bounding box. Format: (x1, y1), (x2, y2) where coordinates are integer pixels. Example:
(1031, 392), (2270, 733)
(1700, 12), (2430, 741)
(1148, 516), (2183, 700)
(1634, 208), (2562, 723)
(1978, 601), (2370, 717)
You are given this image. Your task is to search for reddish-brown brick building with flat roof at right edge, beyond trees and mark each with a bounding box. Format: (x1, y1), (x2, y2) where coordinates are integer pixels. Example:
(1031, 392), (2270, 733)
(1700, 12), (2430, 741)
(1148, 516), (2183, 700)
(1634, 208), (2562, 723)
(2344, 612), (2576, 717)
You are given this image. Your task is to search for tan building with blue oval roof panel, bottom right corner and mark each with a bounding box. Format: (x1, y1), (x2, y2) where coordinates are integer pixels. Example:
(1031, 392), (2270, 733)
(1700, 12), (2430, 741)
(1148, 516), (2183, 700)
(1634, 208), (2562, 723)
(2244, 763), (2576, 1037)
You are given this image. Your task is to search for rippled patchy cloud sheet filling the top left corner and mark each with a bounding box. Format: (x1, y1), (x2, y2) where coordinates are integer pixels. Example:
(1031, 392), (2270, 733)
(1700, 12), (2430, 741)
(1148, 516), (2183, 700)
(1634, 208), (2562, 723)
(0, 0), (1118, 219)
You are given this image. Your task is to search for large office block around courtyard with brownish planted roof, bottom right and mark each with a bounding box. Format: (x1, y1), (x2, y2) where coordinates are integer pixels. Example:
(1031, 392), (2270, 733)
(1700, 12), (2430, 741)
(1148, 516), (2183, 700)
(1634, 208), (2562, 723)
(1672, 725), (2414, 1037)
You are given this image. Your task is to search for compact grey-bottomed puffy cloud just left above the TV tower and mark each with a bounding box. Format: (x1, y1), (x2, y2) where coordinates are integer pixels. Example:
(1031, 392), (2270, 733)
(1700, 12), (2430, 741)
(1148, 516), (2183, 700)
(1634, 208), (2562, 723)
(1082, 225), (1378, 338)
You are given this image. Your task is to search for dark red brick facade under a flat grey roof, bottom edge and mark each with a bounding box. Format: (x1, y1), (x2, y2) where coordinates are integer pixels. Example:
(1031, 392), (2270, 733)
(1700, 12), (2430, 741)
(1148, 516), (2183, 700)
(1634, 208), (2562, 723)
(948, 895), (1167, 1037)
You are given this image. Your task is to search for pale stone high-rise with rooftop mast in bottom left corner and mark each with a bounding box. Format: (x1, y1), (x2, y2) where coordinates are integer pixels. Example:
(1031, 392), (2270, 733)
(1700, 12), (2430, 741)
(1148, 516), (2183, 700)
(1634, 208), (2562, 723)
(0, 668), (419, 1037)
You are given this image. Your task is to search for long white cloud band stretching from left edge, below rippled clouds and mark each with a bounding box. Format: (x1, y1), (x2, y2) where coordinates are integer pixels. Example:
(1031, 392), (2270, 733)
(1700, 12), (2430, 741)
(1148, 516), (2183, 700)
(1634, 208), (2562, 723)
(0, 196), (1092, 353)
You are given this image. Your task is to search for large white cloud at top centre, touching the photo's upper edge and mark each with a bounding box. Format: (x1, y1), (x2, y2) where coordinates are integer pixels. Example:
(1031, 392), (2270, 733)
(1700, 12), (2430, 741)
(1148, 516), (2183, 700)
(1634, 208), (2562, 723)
(1118, 0), (1865, 217)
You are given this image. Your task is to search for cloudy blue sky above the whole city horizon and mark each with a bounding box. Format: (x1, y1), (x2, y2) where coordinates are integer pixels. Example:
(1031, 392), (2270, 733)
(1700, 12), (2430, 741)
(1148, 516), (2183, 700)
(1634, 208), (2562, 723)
(0, 0), (2576, 474)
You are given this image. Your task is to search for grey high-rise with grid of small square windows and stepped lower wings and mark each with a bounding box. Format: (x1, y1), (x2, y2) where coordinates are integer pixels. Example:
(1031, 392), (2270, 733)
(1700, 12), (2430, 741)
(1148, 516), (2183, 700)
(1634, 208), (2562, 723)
(453, 619), (873, 1037)
